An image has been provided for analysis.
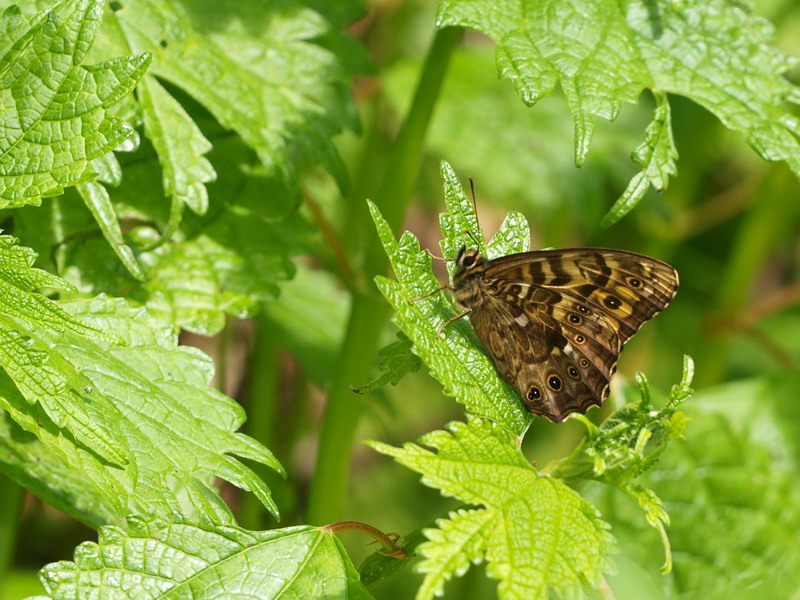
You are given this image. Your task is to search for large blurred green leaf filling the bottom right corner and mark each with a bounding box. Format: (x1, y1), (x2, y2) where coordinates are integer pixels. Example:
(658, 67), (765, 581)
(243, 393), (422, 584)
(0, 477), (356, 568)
(598, 404), (800, 600)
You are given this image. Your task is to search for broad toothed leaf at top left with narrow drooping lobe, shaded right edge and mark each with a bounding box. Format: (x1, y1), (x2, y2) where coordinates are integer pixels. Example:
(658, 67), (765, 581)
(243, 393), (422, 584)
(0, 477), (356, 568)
(102, 0), (356, 191)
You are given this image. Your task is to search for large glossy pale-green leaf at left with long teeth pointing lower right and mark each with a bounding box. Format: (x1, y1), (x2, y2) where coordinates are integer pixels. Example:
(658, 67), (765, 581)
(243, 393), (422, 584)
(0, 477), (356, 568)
(0, 298), (282, 526)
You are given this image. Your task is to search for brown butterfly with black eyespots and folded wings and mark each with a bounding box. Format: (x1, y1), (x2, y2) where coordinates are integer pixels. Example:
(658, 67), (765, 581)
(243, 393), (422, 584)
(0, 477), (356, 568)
(448, 248), (678, 423)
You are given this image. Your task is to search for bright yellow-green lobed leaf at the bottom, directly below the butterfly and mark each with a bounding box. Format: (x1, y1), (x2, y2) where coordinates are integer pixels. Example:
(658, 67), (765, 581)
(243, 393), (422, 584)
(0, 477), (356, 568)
(371, 417), (613, 600)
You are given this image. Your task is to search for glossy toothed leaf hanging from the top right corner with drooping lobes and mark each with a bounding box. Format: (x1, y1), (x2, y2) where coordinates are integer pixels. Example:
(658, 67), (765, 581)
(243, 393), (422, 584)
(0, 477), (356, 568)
(437, 0), (800, 225)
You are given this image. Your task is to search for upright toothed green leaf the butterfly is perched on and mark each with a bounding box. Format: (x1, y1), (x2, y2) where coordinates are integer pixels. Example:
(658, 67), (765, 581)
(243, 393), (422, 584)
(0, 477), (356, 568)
(370, 163), (532, 433)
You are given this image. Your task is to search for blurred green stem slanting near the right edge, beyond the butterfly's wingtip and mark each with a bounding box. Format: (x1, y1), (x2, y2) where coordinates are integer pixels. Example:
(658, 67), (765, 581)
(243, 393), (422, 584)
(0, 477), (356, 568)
(697, 165), (798, 386)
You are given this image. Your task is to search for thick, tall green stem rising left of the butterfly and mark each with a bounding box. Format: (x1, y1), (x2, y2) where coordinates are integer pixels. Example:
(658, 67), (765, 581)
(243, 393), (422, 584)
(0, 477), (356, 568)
(308, 28), (461, 524)
